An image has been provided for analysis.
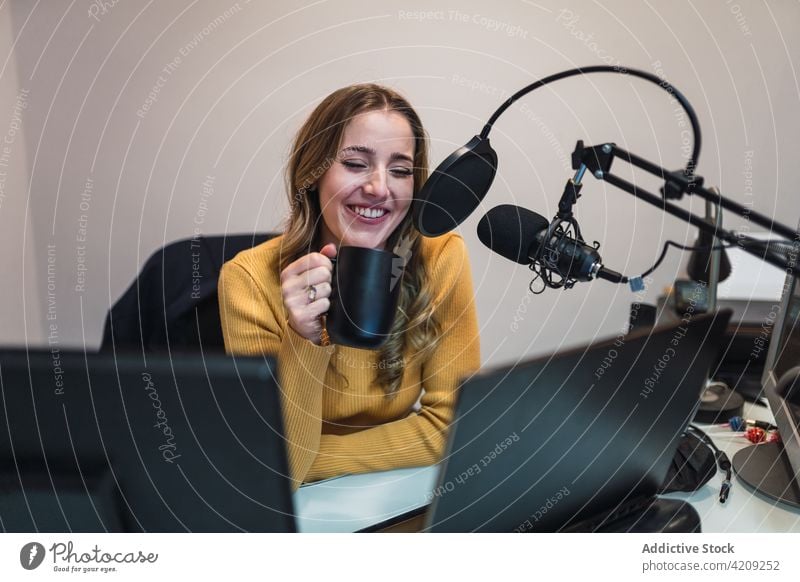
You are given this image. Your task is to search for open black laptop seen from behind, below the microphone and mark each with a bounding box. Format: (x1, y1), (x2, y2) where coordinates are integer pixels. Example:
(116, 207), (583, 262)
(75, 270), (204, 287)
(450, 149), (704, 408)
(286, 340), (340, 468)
(425, 310), (731, 532)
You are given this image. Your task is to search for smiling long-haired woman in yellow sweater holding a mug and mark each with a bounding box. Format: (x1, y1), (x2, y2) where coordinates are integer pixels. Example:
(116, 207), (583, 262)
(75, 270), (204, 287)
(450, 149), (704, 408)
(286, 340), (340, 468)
(219, 84), (480, 485)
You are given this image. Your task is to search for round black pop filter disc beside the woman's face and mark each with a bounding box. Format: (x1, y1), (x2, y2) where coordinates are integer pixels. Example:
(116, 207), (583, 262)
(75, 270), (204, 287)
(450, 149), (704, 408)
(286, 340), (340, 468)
(411, 135), (497, 237)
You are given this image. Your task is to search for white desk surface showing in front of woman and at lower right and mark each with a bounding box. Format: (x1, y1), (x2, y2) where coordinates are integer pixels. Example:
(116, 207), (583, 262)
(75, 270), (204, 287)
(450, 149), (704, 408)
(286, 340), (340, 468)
(294, 405), (800, 533)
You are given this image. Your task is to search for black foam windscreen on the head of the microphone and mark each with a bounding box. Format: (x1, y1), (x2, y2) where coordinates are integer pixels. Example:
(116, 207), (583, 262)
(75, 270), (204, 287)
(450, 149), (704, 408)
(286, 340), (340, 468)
(478, 204), (550, 265)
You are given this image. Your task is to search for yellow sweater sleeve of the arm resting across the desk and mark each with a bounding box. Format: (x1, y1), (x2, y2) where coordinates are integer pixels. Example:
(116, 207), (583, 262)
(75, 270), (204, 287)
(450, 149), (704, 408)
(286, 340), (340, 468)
(304, 236), (480, 481)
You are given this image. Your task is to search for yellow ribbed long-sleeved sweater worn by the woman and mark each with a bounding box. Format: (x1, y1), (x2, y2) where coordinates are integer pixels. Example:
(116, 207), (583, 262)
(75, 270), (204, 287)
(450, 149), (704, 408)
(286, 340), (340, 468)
(219, 233), (480, 486)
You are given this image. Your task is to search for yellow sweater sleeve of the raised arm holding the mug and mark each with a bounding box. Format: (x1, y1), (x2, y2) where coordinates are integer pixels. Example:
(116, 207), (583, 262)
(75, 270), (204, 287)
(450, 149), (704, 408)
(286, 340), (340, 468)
(218, 261), (333, 487)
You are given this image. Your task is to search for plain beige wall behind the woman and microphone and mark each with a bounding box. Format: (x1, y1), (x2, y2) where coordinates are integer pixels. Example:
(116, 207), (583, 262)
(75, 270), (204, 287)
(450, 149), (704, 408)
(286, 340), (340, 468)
(0, 0), (800, 363)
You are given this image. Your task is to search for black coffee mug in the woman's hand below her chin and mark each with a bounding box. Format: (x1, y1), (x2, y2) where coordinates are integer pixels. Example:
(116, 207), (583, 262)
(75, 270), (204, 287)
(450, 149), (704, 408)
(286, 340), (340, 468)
(326, 247), (403, 350)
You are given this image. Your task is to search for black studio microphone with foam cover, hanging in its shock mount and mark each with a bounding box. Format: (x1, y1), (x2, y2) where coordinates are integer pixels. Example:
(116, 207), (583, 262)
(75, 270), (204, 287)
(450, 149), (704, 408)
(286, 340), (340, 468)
(478, 204), (627, 293)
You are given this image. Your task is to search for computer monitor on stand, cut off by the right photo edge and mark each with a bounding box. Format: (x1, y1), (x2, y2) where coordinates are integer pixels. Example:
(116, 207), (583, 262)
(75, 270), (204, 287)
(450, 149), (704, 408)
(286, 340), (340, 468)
(733, 241), (800, 507)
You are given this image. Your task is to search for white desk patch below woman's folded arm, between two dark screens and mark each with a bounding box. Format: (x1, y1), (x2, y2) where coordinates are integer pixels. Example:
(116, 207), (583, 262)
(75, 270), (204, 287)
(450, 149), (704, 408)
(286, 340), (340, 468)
(294, 465), (439, 533)
